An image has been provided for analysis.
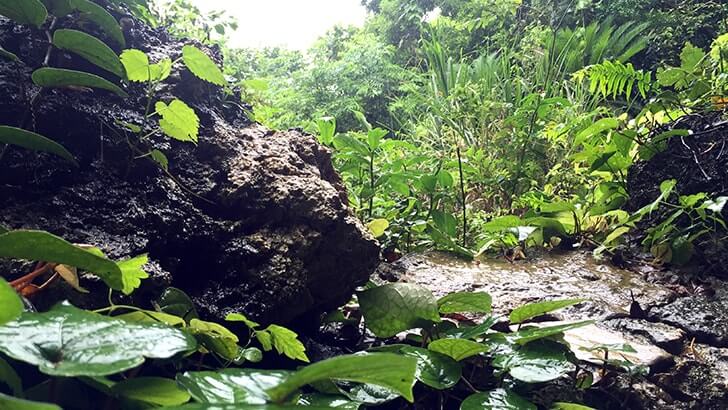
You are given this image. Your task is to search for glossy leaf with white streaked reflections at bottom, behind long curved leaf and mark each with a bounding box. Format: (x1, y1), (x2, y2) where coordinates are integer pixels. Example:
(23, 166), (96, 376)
(177, 369), (291, 404)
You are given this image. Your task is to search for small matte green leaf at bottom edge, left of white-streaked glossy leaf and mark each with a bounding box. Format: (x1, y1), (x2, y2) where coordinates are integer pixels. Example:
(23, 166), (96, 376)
(111, 377), (190, 406)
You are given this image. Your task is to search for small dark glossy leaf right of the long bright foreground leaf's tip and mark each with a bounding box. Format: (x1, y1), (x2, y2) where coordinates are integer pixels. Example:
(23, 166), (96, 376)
(401, 346), (463, 390)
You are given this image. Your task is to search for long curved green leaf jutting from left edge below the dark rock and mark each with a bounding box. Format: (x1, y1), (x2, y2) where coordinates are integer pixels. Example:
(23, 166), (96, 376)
(0, 230), (124, 290)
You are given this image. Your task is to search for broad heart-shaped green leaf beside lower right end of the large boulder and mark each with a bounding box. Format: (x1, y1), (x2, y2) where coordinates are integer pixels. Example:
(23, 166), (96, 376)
(357, 283), (440, 337)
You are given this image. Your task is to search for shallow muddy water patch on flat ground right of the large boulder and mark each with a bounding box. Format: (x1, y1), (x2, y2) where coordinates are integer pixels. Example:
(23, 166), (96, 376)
(396, 252), (672, 319)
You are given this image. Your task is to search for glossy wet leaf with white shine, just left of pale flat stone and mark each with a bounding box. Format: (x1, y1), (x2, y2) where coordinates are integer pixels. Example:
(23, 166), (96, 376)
(493, 340), (576, 383)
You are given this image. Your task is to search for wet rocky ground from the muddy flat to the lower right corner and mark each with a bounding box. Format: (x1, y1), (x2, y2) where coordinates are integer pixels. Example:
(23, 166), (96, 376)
(384, 252), (728, 410)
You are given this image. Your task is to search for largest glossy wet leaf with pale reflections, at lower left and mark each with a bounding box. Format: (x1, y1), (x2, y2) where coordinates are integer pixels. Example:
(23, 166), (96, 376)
(0, 303), (196, 377)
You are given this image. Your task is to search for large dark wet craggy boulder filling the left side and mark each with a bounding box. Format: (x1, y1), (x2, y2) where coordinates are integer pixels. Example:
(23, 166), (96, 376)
(0, 3), (379, 323)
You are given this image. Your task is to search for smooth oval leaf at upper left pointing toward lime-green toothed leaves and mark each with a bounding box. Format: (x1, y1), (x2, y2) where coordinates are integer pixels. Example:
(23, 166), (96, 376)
(53, 29), (125, 78)
